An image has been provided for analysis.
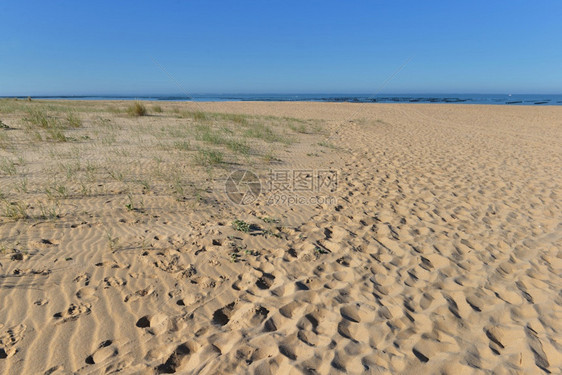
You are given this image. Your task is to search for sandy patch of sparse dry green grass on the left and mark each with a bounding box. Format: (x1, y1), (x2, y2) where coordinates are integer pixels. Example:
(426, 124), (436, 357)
(0, 99), (322, 222)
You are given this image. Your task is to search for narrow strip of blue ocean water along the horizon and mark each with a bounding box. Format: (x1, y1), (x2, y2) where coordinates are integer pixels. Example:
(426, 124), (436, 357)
(4, 94), (562, 105)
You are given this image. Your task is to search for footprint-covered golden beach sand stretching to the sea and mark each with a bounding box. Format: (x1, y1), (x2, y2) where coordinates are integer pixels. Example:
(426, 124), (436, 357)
(0, 102), (562, 375)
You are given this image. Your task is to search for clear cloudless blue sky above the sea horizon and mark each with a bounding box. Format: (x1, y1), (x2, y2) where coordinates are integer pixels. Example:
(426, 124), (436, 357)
(0, 0), (562, 95)
